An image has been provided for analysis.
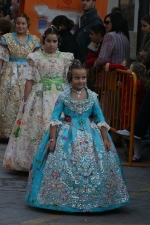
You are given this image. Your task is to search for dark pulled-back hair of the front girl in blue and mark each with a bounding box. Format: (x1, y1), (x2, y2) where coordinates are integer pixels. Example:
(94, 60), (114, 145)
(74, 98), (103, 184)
(67, 59), (87, 83)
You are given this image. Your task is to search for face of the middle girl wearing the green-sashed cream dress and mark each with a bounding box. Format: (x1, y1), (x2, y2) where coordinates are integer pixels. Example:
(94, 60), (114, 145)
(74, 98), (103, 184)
(44, 34), (58, 53)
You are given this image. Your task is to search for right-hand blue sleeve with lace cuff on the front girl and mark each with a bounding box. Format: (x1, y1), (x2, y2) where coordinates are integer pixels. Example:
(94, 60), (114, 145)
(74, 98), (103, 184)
(92, 99), (110, 130)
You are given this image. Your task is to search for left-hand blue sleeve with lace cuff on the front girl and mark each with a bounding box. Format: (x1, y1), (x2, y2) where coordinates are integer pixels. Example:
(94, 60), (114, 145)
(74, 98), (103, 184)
(50, 96), (64, 126)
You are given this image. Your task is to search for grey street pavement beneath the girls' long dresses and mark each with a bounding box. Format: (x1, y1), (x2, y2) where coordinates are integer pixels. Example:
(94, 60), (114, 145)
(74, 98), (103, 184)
(0, 140), (150, 225)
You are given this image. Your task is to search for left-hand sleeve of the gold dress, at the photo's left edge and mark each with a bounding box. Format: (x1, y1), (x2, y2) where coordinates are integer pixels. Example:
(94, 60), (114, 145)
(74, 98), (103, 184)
(0, 37), (9, 62)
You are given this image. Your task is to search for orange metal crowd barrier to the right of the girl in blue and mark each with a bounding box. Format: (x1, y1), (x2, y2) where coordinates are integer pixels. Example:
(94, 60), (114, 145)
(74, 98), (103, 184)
(93, 68), (150, 167)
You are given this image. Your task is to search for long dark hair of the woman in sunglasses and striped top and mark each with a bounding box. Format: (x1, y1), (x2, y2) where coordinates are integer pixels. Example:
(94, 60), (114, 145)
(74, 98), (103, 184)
(104, 12), (129, 40)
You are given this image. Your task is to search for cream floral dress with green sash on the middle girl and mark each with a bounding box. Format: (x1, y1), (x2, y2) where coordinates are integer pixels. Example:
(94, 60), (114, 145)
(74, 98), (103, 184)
(3, 51), (73, 171)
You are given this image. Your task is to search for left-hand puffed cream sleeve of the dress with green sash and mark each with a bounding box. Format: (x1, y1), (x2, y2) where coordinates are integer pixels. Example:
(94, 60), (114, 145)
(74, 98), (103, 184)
(23, 52), (41, 83)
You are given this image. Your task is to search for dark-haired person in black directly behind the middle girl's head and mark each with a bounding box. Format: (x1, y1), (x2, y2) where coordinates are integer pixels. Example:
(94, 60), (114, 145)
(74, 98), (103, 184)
(52, 15), (77, 54)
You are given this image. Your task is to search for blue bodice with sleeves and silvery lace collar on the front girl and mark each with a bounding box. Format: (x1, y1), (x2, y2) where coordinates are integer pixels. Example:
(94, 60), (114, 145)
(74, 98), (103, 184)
(51, 88), (109, 129)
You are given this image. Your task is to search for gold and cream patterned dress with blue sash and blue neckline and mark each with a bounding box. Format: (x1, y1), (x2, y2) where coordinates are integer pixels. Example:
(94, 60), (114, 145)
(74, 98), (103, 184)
(0, 33), (40, 137)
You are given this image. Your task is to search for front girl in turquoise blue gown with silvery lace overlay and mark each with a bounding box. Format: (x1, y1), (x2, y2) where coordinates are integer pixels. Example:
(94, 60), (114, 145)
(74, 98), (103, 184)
(26, 60), (130, 212)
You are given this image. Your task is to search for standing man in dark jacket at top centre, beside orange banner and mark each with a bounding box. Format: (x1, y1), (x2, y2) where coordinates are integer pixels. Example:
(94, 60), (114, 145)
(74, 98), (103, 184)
(74, 0), (103, 63)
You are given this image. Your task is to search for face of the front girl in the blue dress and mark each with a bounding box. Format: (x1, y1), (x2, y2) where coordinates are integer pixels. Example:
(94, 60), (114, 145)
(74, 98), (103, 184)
(72, 68), (87, 91)
